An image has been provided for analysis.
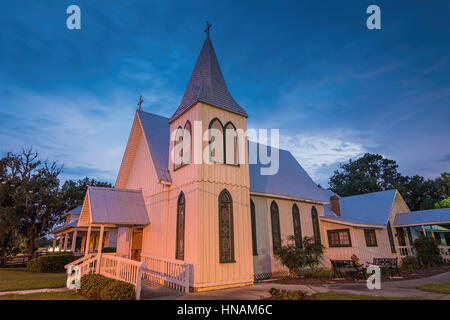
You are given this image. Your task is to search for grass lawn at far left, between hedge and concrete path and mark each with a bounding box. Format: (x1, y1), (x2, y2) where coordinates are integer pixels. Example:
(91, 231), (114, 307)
(0, 268), (67, 291)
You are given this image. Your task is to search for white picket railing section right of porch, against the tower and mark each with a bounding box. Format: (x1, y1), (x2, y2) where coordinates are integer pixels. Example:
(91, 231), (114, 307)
(141, 254), (190, 293)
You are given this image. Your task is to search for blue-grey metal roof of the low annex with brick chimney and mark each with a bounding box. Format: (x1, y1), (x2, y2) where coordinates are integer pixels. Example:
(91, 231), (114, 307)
(324, 189), (397, 226)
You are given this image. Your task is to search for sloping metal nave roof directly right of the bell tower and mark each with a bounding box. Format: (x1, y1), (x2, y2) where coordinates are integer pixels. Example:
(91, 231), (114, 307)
(248, 141), (329, 202)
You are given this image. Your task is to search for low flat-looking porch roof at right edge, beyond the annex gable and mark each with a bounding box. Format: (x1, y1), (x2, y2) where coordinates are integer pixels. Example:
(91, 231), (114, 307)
(394, 208), (450, 227)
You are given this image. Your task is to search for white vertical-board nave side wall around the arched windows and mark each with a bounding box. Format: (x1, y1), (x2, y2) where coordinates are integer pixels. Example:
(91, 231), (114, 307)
(249, 195), (326, 278)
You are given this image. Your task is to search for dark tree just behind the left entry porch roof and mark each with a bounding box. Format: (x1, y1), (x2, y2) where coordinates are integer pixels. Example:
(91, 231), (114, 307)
(60, 177), (112, 210)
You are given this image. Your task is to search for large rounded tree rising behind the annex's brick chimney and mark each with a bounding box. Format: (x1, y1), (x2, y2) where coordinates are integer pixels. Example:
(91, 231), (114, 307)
(329, 153), (401, 197)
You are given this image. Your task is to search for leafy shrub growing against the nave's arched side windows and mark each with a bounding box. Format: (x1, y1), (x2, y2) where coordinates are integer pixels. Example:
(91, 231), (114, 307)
(275, 236), (324, 278)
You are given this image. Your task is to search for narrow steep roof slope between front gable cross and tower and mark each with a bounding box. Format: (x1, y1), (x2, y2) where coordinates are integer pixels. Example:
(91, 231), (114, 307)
(137, 111), (172, 182)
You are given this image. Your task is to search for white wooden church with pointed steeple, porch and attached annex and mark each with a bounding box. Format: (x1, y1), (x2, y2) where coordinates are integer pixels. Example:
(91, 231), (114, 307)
(53, 26), (450, 291)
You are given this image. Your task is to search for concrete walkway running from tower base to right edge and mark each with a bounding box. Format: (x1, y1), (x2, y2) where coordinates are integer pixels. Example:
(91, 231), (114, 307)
(171, 272), (450, 300)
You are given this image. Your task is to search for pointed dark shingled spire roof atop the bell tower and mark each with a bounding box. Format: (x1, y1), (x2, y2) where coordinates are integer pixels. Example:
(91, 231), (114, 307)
(169, 37), (248, 122)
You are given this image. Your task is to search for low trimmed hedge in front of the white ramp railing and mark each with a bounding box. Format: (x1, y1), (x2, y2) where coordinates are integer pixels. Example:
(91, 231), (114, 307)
(80, 274), (136, 300)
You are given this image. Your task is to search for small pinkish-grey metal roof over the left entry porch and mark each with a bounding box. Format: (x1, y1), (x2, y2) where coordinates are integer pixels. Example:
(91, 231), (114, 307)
(81, 187), (150, 225)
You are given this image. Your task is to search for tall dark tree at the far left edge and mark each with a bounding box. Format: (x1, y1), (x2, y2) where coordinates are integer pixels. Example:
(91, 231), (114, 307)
(1, 148), (64, 254)
